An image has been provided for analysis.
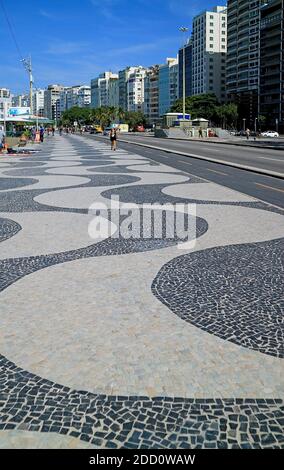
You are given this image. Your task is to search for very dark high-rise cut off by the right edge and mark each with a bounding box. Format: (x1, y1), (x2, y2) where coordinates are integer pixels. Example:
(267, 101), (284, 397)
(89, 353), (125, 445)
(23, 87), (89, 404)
(259, 0), (284, 133)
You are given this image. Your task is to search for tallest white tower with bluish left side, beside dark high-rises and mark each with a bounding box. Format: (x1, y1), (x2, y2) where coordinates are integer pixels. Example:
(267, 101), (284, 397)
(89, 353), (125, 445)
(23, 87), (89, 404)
(192, 6), (227, 101)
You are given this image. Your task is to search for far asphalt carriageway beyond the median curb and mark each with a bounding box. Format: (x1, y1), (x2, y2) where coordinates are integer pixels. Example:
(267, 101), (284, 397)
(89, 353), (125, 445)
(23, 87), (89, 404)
(118, 134), (284, 175)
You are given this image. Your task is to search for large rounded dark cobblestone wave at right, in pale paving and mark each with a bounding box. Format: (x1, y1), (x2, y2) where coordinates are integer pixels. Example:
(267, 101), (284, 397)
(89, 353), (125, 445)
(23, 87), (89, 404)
(152, 238), (284, 358)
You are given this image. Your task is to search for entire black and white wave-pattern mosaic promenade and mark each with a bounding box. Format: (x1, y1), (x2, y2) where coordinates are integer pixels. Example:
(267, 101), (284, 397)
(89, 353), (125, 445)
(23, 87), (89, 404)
(0, 136), (284, 449)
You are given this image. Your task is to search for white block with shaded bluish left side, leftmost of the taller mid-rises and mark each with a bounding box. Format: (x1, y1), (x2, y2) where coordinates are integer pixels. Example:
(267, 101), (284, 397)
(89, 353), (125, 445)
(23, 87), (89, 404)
(91, 72), (118, 108)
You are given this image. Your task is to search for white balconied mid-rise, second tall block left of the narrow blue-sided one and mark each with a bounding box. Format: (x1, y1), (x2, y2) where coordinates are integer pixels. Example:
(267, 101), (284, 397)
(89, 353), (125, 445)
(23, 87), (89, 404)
(126, 66), (147, 112)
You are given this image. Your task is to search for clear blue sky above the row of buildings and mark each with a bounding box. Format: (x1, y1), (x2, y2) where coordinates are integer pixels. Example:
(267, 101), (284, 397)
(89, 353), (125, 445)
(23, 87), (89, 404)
(0, 0), (226, 93)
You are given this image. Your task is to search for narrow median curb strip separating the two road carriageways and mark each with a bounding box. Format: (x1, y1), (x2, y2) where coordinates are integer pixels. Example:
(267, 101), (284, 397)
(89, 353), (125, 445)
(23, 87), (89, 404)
(116, 139), (284, 179)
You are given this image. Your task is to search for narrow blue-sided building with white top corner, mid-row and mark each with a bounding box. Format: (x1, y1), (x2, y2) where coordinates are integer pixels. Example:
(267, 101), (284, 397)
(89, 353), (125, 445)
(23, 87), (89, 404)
(158, 58), (179, 117)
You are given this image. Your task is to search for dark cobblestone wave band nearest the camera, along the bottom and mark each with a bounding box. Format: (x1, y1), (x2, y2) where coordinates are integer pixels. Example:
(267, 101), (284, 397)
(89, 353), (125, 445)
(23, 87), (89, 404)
(0, 357), (284, 449)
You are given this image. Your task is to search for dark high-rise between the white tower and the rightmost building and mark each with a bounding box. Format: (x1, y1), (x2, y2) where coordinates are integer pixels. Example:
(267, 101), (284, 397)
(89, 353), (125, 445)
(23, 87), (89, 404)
(226, 0), (267, 128)
